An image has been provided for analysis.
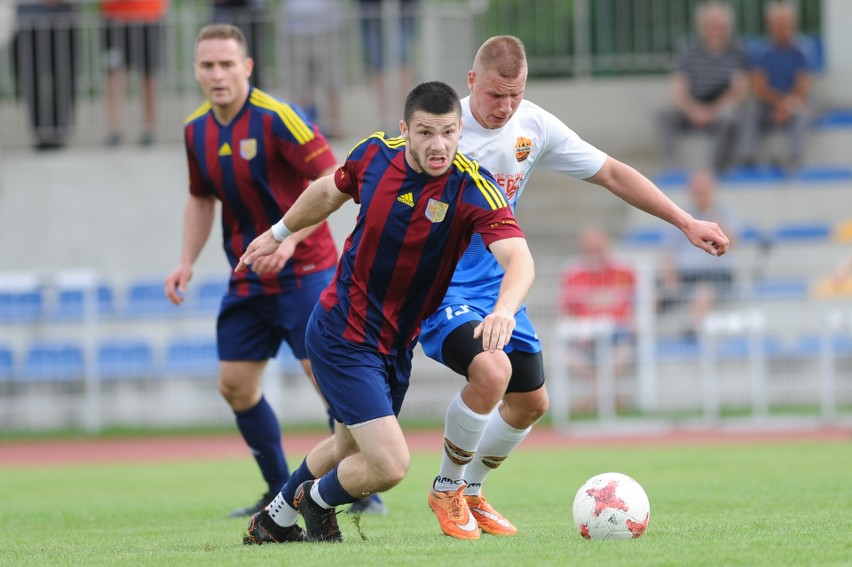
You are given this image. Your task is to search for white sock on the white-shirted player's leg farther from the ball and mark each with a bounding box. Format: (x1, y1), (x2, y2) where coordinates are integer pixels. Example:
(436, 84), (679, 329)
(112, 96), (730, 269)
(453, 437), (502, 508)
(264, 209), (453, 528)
(434, 392), (491, 492)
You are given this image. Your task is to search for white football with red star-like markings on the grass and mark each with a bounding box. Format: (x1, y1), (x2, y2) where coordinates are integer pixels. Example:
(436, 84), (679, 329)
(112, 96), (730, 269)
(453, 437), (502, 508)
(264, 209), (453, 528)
(573, 473), (651, 539)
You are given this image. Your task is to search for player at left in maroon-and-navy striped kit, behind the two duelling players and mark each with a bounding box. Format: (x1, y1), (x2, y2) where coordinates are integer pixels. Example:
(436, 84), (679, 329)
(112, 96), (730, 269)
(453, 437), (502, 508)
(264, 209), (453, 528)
(164, 24), (337, 516)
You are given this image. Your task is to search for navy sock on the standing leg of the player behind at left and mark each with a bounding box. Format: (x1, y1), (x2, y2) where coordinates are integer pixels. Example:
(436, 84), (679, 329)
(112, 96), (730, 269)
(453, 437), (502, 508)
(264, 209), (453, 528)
(234, 397), (290, 492)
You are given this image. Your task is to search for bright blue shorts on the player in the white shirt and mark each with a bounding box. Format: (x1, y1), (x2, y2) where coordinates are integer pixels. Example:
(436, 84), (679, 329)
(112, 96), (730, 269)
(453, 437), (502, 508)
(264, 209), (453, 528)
(419, 295), (541, 364)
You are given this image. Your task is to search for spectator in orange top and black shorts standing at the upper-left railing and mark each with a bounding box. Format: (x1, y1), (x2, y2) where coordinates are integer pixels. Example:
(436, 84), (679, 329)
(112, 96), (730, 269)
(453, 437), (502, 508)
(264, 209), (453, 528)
(101, 0), (169, 146)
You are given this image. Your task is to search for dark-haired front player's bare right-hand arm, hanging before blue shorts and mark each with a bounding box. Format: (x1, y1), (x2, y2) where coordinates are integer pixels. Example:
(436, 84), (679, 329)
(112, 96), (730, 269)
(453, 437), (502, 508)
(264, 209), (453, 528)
(473, 237), (535, 351)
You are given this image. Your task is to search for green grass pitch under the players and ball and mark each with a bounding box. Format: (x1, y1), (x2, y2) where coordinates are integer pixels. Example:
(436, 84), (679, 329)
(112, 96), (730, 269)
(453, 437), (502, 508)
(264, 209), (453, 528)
(0, 442), (852, 567)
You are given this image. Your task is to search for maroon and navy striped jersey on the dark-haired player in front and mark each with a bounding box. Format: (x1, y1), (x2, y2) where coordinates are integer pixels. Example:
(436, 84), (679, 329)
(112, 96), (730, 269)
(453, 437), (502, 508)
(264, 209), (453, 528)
(320, 133), (523, 355)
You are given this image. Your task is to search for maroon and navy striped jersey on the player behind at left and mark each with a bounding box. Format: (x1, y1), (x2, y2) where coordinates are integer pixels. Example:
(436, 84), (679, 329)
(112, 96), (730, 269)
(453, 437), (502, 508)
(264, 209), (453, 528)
(184, 88), (337, 296)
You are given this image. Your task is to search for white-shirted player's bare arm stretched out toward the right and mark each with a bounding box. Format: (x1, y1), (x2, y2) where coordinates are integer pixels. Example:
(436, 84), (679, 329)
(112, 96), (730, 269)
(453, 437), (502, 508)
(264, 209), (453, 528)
(586, 157), (730, 256)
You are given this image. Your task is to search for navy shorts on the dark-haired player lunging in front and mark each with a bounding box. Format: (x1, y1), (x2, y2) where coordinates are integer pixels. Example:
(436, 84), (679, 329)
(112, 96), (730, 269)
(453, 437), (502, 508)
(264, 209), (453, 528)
(305, 305), (412, 426)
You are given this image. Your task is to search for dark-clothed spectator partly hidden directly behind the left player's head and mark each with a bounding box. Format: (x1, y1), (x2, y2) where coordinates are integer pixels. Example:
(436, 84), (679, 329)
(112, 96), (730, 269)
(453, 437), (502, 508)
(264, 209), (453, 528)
(212, 0), (269, 90)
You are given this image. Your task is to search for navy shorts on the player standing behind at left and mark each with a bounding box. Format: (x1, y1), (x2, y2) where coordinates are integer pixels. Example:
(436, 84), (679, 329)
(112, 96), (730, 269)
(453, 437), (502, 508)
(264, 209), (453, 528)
(217, 268), (337, 360)
